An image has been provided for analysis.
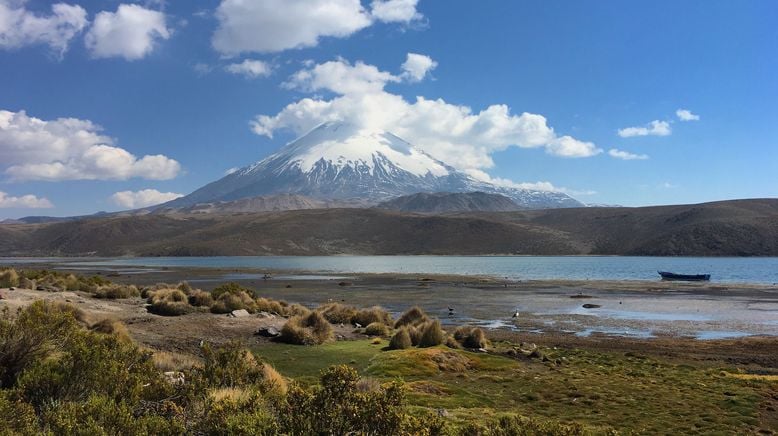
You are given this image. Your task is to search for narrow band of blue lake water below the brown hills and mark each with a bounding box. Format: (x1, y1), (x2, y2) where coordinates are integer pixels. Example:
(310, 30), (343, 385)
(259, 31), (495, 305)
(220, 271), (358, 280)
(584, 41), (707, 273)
(9, 256), (778, 284)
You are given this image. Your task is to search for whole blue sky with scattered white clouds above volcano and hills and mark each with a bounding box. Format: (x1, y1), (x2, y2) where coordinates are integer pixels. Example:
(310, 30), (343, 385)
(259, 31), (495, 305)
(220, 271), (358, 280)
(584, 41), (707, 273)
(0, 0), (778, 218)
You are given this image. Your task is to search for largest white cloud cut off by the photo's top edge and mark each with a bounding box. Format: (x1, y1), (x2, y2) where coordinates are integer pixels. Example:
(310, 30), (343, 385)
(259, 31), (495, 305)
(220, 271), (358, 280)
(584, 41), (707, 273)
(212, 0), (372, 55)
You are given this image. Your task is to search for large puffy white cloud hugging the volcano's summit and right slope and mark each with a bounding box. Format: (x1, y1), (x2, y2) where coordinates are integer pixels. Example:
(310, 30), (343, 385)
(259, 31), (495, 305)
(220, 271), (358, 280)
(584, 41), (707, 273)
(251, 59), (602, 174)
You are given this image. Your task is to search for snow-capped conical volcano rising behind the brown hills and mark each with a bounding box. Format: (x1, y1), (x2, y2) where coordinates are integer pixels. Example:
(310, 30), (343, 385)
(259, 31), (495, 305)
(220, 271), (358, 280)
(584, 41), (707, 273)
(163, 122), (583, 208)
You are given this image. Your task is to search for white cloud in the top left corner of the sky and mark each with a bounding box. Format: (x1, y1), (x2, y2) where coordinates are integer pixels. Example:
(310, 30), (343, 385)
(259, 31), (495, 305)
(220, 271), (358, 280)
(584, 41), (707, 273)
(0, 0), (88, 56)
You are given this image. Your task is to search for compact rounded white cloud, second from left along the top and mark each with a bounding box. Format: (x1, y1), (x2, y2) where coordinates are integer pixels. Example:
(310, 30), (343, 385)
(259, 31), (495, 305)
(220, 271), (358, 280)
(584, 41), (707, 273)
(84, 4), (171, 61)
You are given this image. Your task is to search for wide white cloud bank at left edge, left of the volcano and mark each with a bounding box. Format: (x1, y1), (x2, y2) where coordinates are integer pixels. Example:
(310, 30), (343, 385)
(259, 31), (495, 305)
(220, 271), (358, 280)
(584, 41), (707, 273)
(0, 110), (181, 181)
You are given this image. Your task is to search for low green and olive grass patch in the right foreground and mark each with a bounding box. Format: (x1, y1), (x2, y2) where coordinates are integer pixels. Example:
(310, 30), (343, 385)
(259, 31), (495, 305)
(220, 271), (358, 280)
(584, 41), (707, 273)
(255, 340), (764, 434)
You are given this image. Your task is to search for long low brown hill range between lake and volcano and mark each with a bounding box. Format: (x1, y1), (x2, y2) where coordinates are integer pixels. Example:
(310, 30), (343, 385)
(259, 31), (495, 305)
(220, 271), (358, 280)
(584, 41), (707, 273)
(0, 199), (778, 256)
